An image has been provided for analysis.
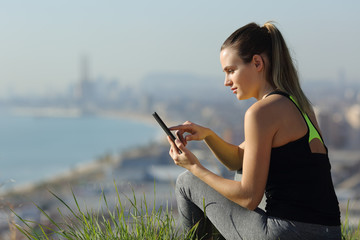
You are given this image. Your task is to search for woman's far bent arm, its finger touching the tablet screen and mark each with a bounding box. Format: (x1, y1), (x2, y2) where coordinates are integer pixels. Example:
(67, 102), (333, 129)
(170, 121), (245, 170)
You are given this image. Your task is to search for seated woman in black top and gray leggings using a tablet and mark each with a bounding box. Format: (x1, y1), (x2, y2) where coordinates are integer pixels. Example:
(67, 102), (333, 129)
(168, 22), (341, 239)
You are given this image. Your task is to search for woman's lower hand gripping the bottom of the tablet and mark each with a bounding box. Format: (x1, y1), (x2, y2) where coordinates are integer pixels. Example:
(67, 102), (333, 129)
(167, 137), (200, 171)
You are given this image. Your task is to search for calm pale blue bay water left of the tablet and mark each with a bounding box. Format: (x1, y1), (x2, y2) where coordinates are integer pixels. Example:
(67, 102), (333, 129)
(0, 115), (159, 190)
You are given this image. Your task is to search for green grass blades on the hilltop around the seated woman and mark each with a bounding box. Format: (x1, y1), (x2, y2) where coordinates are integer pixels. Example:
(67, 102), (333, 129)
(9, 184), (360, 240)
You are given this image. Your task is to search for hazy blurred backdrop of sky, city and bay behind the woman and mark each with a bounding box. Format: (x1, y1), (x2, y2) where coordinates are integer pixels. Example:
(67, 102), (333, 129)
(0, 0), (360, 237)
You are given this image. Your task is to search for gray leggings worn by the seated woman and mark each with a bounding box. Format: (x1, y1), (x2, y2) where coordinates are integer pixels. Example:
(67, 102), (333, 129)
(175, 171), (341, 240)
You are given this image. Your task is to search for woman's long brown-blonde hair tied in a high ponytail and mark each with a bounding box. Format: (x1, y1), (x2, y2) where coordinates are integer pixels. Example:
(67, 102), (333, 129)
(221, 22), (312, 113)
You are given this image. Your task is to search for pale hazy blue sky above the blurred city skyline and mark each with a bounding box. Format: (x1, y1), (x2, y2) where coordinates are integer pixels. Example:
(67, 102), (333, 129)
(0, 0), (360, 98)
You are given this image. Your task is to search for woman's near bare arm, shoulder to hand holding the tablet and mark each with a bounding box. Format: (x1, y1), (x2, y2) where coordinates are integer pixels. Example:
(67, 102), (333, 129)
(169, 103), (276, 210)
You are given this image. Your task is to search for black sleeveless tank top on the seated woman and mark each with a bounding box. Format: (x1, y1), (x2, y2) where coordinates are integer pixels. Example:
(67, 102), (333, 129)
(265, 92), (340, 226)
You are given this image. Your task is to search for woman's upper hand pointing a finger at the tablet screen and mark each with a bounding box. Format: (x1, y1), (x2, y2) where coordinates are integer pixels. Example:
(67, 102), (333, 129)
(169, 121), (211, 146)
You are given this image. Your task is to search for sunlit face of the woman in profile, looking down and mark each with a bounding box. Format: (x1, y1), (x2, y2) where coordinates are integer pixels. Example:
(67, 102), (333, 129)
(220, 48), (258, 100)
